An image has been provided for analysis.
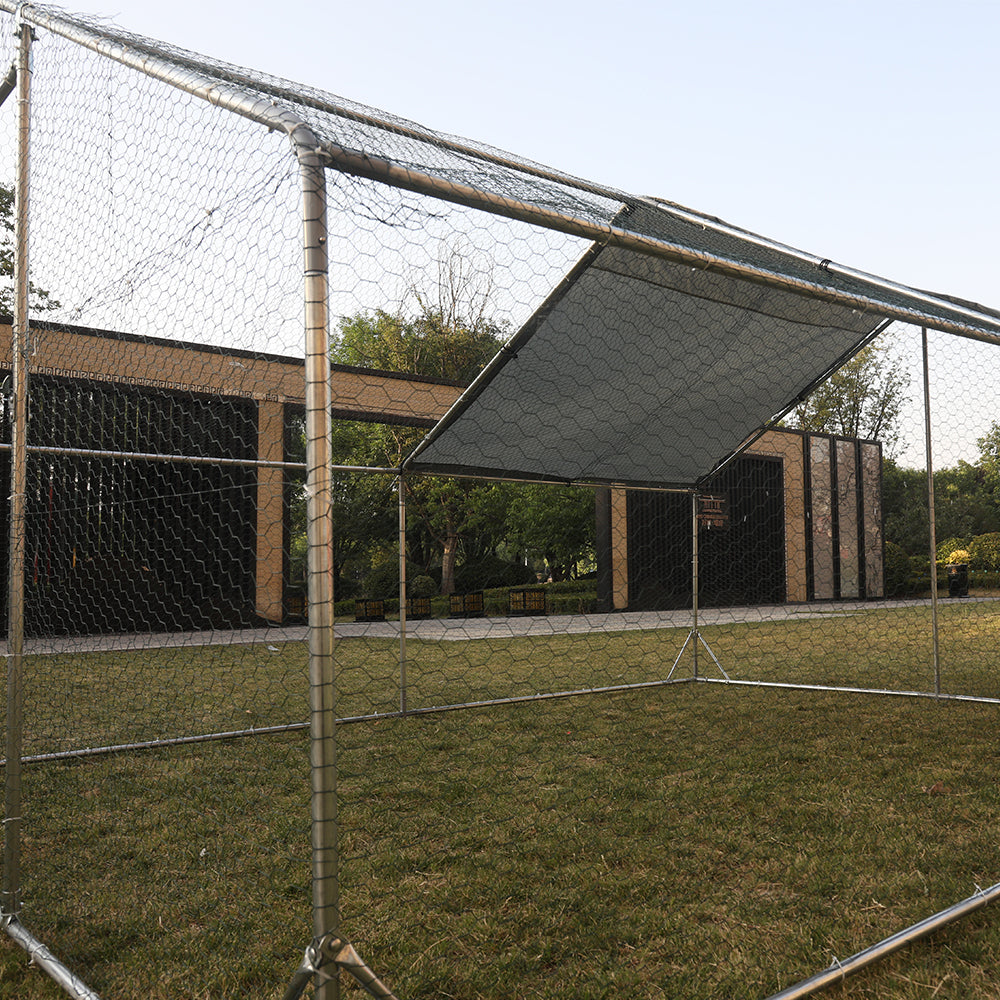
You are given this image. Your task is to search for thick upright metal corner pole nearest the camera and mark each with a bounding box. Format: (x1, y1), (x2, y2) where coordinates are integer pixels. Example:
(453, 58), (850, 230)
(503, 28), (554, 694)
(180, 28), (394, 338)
(298, 145), (340, 1000)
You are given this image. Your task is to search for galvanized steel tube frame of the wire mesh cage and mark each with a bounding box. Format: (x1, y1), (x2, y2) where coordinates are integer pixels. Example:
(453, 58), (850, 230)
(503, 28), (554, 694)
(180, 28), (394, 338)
(0, 0), (1000, 1000)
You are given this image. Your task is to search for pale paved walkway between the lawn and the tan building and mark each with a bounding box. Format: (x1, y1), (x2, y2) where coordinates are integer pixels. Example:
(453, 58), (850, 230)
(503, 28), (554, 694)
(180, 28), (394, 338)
(7, 597), (1000, 654)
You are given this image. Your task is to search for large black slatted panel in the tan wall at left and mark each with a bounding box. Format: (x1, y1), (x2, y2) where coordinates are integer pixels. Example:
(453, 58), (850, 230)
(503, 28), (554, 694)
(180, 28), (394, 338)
(0, 376), (257, 635)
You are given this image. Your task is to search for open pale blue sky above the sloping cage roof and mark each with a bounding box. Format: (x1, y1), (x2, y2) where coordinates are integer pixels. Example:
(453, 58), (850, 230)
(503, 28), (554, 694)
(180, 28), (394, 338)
(29, 0), (1000, 464)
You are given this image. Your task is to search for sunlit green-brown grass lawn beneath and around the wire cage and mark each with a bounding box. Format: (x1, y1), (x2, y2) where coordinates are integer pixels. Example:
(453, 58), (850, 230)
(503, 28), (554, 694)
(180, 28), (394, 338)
(0, 604), (1000, 1000)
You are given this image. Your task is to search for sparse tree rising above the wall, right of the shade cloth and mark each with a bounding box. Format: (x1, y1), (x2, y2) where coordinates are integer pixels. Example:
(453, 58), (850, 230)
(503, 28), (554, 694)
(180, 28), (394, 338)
(786, 339), (910, 457)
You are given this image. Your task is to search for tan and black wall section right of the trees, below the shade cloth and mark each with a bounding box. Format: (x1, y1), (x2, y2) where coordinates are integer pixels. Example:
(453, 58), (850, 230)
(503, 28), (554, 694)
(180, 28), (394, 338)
(597, 430), (884, 610)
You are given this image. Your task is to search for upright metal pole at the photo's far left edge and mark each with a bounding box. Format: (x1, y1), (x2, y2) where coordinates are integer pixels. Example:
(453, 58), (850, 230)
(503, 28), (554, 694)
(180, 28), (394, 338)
(2, 24), (31, 917)
